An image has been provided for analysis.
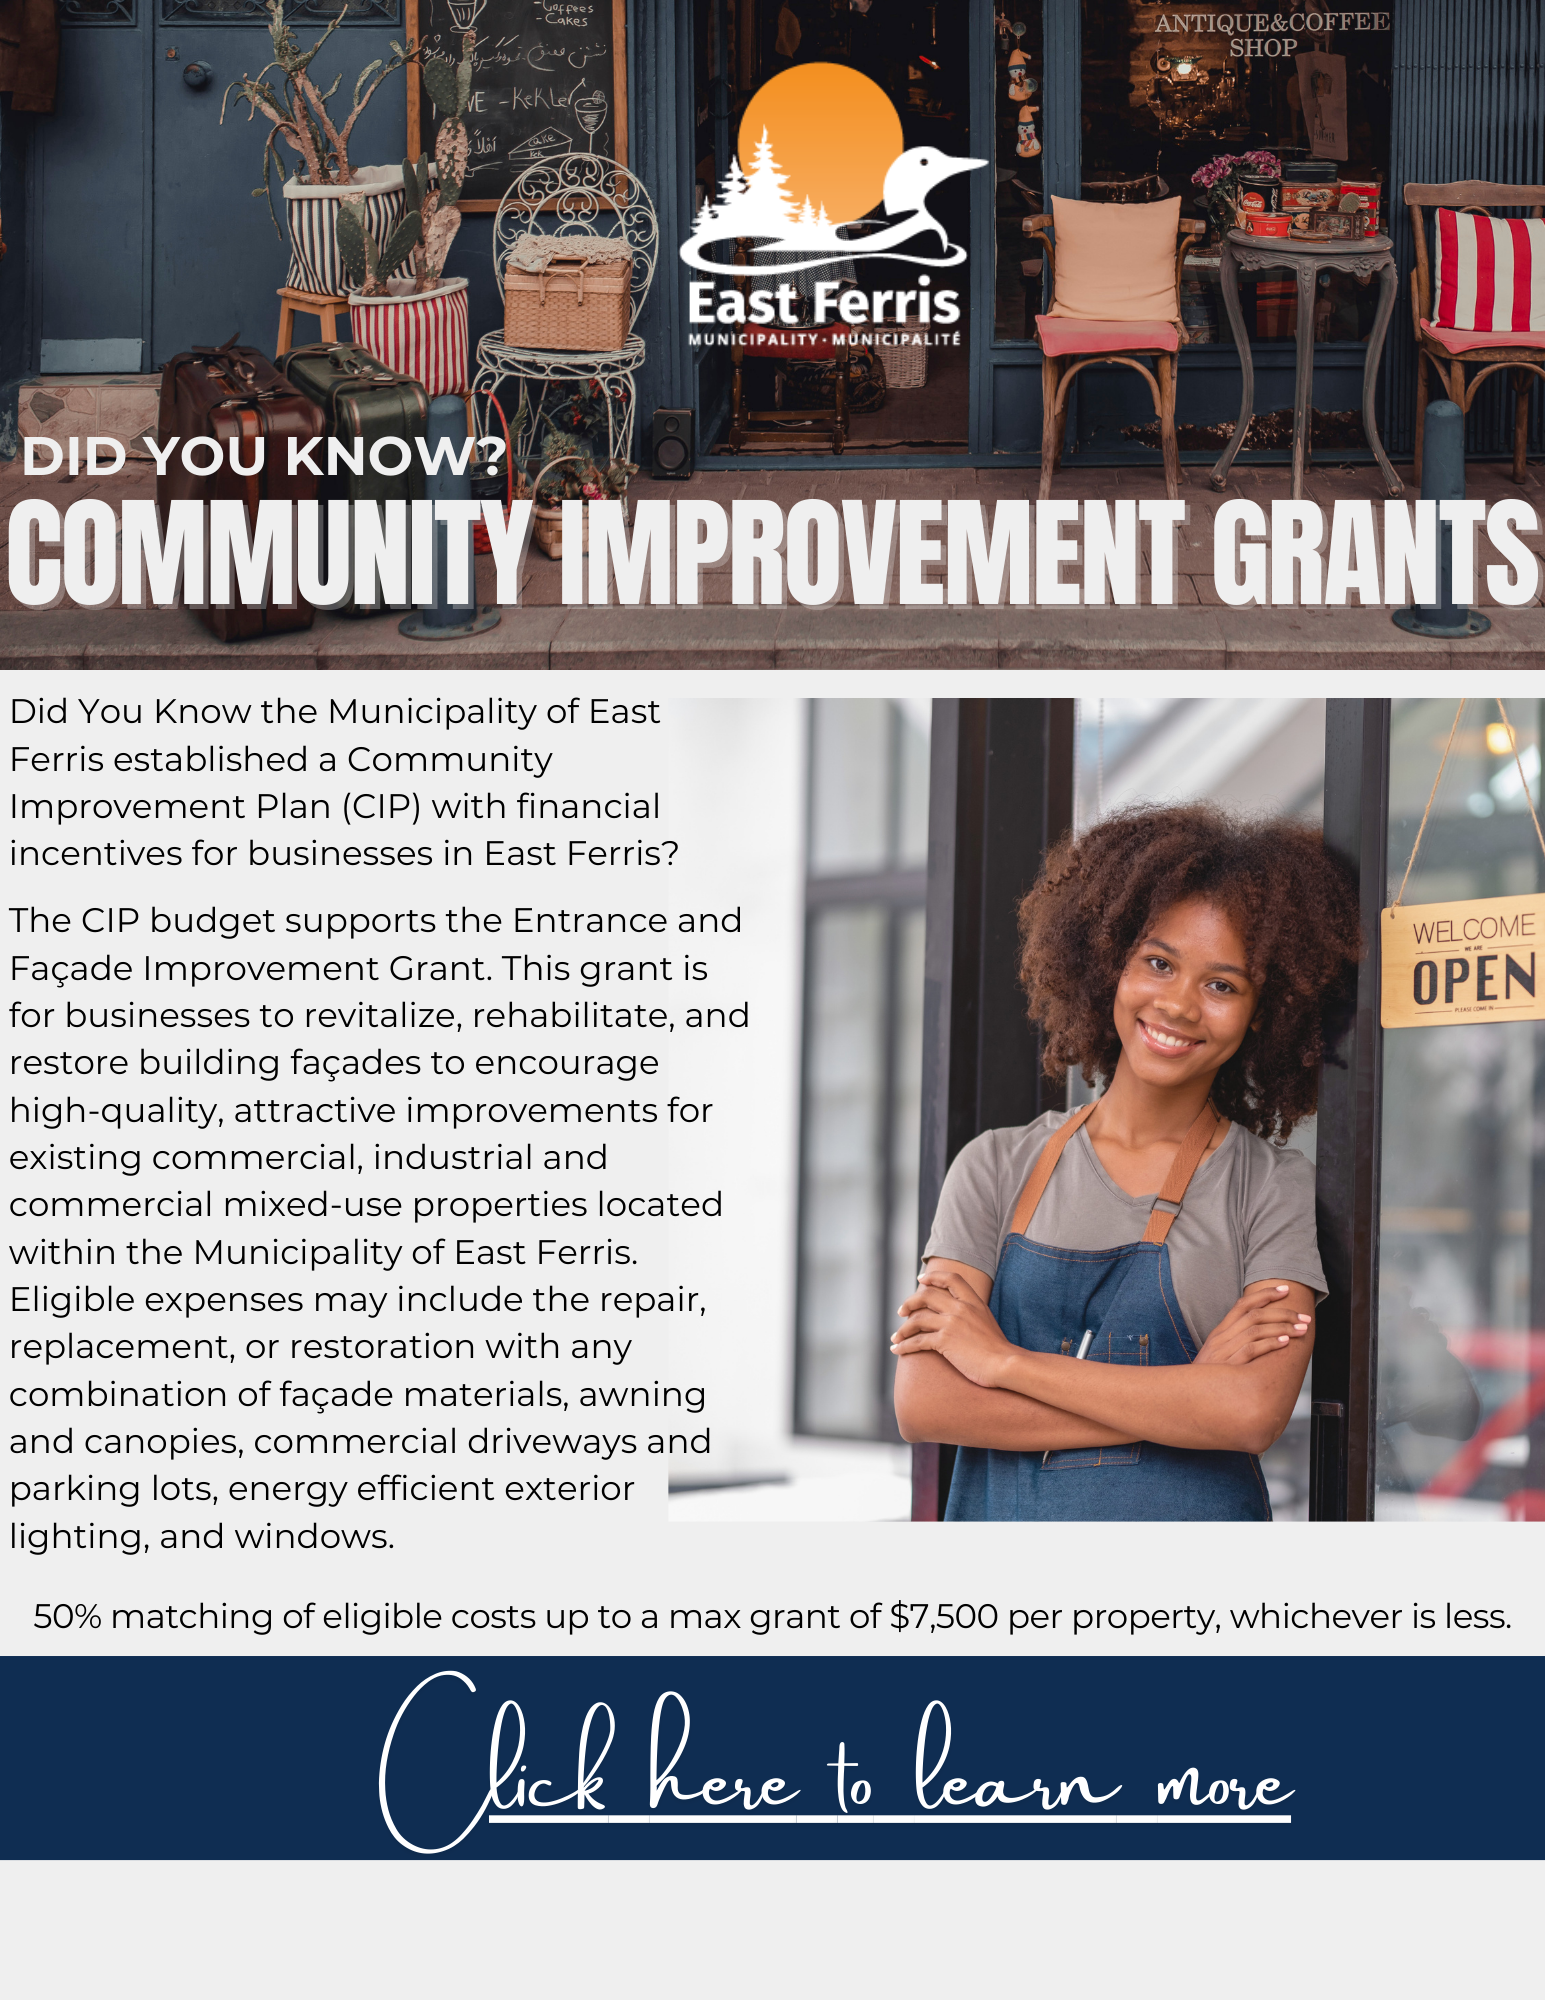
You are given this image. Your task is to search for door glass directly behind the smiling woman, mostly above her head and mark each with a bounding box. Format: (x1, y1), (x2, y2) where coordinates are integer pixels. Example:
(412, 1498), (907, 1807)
(1069, 700), (1325, 1520)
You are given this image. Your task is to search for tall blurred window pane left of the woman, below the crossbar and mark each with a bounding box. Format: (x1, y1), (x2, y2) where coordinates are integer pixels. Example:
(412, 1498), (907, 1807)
(799, 908), (887, 1438)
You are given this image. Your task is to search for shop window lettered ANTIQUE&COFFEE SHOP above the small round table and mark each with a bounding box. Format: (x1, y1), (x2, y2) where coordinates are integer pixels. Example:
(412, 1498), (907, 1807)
(1083, 0), (1393, 342)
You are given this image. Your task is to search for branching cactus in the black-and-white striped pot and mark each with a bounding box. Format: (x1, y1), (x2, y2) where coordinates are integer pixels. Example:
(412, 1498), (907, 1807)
(220, 0), (416, 294)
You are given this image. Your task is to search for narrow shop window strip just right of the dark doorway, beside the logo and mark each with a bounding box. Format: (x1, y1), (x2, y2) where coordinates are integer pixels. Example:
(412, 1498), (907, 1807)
(993, 0), (1047, 340)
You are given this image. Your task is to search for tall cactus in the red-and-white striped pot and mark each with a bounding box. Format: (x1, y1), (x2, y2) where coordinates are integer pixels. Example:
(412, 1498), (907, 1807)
(338, 28), (476, 396)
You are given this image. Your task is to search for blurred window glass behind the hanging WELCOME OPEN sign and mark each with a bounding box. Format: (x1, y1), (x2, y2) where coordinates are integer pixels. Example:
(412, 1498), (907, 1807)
(1375, 702), (1545, 1520)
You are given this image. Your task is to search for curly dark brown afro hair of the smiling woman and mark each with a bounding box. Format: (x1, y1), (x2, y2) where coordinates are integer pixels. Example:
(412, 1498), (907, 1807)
(1019, 806), (1363, 1144)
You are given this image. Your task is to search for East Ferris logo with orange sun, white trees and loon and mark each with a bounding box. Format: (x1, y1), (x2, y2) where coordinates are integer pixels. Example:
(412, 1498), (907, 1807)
(680, 62), (987, 326)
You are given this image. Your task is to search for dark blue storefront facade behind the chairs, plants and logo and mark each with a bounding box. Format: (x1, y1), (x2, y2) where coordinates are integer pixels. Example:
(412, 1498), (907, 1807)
(0, 0), (1545, 466)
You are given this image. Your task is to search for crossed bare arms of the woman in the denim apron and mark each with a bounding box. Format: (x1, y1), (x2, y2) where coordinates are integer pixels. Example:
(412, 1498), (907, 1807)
(891, 1258), (1315, 1452)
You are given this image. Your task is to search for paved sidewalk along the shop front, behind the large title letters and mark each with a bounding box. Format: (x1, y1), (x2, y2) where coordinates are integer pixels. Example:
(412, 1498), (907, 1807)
(0, 460), (1545, 672)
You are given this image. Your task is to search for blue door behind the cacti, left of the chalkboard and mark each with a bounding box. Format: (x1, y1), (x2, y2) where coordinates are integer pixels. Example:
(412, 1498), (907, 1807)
(36, 0), (406, 374)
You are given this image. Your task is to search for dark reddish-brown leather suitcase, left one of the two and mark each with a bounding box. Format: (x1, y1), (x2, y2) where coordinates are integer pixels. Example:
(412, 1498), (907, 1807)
(156, 340), (326, 640)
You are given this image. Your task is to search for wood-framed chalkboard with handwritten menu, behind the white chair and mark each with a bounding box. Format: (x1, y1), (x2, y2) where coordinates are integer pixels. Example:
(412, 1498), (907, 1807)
(408, 0), (628, 210)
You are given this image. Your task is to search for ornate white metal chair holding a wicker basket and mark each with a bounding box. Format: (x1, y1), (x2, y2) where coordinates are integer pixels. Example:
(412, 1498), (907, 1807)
(472, 152), (660, 466)
